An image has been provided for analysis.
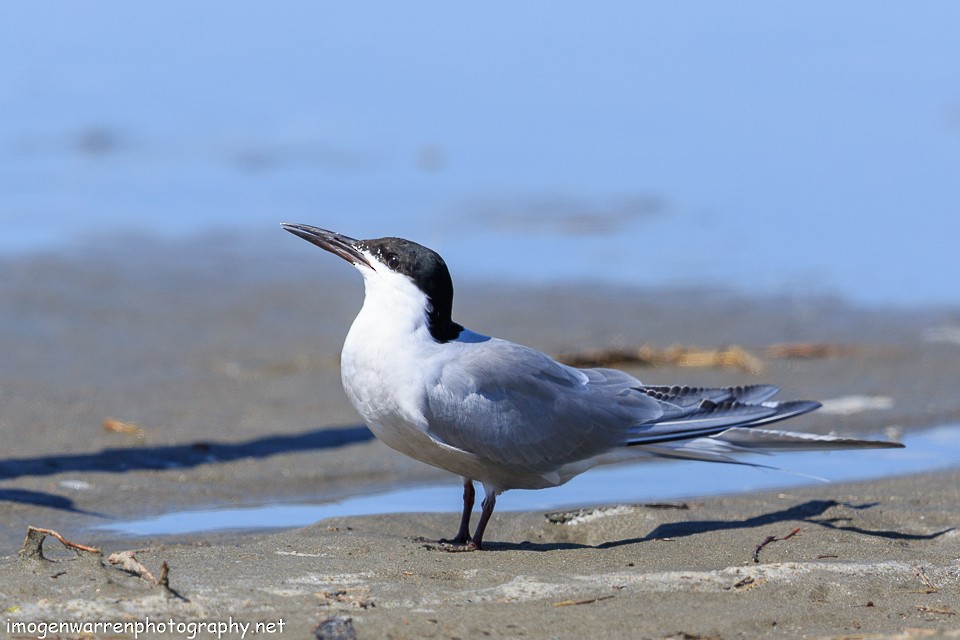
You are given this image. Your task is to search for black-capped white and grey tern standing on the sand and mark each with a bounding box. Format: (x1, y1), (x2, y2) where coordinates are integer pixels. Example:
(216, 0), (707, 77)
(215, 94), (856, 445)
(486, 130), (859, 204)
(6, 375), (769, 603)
(281, 223), (902, 551)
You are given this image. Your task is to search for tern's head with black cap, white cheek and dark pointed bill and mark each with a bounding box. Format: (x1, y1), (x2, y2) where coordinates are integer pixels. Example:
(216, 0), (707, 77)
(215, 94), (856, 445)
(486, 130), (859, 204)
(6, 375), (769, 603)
(281, 223), (463, 342)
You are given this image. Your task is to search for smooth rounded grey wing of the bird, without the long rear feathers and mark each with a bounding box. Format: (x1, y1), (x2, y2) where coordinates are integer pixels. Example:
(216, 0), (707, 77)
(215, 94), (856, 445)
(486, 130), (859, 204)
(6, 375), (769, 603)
(427, 338), (663, 472)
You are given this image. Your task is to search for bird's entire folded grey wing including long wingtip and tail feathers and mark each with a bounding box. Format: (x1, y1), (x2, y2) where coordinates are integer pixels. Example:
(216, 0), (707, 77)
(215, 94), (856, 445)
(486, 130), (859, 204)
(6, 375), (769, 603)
(426, 338), (895, 473)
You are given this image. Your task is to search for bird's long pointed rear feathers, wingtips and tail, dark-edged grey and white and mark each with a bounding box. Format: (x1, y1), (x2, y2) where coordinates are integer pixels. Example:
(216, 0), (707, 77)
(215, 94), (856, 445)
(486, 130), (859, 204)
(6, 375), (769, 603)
(627, 385), (903, 466)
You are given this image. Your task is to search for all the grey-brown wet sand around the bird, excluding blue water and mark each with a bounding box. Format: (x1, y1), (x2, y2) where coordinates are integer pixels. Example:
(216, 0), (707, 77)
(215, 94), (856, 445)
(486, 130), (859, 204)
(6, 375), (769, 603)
(0, 241), (960, 638)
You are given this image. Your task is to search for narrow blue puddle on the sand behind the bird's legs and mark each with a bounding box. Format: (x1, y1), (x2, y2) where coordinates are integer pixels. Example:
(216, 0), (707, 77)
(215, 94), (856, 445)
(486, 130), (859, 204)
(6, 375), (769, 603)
(96, 424), (960, 536)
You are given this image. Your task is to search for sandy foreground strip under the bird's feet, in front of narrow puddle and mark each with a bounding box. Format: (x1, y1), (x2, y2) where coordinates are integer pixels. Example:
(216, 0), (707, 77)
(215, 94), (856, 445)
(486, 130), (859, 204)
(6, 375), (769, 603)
(0, 470), (960, 638)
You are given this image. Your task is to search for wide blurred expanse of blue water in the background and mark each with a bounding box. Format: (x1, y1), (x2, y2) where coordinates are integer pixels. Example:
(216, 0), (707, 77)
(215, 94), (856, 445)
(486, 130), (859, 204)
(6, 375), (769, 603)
(0, 0), (960, 305)
